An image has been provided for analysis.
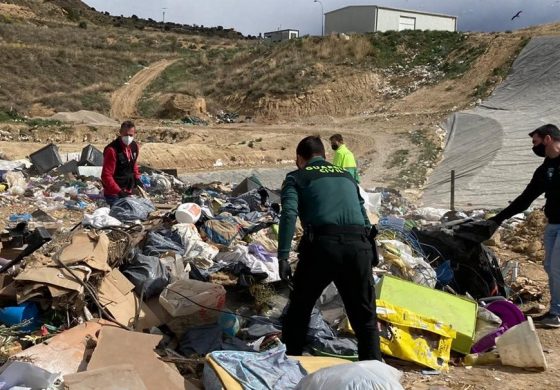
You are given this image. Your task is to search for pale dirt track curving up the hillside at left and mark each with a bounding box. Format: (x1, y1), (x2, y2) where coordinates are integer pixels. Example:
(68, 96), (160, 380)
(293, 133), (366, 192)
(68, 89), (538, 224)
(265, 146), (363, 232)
(111, 59), (177, 121)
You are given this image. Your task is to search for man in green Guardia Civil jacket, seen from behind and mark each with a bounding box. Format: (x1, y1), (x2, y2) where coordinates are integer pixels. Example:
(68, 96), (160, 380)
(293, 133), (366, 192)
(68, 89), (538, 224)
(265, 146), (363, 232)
(278, 136), (381, 360)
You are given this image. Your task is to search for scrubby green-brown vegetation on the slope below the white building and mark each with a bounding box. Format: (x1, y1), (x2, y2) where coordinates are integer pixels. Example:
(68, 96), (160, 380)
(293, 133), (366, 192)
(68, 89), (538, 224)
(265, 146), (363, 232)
(140, 31), (494, 116)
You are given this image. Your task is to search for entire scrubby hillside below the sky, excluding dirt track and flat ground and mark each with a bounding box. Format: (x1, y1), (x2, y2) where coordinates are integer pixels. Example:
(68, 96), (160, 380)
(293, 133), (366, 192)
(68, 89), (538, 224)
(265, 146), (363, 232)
(0, 0), (526, 119)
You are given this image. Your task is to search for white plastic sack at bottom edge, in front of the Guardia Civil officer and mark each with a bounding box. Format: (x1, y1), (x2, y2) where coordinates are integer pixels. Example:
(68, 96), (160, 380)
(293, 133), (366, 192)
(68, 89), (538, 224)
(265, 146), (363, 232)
(296, 360), (403, 390)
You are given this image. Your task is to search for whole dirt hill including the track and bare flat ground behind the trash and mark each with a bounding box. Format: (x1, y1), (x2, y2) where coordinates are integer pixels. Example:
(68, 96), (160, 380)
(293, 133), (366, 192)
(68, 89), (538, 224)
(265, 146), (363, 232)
(0, 0), (559, 189)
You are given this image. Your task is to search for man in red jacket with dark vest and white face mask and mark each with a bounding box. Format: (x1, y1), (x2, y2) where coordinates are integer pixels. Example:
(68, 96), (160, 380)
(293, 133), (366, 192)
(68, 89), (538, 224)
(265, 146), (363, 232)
(101, 121), (143, 206)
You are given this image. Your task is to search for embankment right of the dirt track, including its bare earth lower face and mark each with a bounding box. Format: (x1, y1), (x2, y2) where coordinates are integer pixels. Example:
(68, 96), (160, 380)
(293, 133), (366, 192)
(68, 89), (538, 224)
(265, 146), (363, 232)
(140, 31), (507, 118)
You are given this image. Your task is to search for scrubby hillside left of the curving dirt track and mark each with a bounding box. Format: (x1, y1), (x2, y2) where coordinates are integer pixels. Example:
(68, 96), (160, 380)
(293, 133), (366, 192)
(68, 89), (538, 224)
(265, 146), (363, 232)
(0, 0), (248, 115)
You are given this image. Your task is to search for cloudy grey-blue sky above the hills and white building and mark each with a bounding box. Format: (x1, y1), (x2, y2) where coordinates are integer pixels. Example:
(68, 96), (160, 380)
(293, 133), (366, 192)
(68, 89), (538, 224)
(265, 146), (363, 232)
(85, 0), (560, 35)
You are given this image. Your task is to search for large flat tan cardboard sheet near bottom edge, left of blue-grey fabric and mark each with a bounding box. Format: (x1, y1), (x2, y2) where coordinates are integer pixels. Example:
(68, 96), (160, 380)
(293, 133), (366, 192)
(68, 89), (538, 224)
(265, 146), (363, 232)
(88, 327), (192, 390)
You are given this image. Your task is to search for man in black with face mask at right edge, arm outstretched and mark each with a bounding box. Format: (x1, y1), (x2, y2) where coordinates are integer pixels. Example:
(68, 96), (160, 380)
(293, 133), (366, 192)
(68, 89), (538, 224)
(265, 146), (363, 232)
(486, 124), (560, 328)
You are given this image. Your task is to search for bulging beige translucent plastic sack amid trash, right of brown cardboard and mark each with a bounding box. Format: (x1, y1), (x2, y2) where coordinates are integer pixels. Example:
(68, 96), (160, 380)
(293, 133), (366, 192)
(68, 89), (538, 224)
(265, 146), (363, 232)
(159, 279), (226, 317)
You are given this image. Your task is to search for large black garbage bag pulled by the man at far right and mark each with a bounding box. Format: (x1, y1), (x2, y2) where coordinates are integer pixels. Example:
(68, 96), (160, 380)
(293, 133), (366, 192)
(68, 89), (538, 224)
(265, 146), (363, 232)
(414, 228), (507, 299)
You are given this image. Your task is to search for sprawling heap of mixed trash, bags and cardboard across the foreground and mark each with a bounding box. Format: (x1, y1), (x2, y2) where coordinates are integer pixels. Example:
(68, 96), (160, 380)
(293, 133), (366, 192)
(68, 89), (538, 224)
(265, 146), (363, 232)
(0, 145), (547, 389)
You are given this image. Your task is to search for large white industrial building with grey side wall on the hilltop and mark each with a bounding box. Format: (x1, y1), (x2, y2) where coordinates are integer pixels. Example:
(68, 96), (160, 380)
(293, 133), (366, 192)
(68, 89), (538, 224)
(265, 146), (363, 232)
(325, 5), (457, 35)
